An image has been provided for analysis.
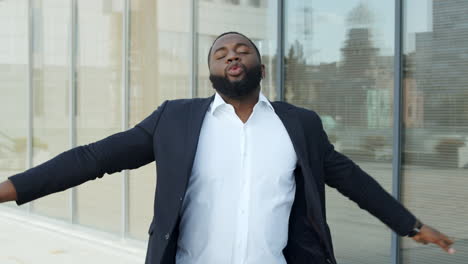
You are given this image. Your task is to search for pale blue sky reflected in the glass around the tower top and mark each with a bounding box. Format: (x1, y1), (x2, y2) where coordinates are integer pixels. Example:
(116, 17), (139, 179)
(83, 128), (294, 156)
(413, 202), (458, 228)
(285, 0), (432, 64)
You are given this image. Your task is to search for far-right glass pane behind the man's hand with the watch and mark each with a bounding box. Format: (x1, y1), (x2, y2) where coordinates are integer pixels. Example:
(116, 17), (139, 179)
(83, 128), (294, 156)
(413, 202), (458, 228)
(402, 0), (468, 264)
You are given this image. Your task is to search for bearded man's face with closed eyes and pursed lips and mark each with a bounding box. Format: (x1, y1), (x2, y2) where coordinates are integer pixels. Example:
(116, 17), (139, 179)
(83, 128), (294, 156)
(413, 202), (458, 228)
(209, 34), (265, 98)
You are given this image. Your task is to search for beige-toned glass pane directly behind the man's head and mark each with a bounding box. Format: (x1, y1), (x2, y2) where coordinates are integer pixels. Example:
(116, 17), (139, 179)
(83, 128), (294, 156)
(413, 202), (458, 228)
(196, 1), (278, 100)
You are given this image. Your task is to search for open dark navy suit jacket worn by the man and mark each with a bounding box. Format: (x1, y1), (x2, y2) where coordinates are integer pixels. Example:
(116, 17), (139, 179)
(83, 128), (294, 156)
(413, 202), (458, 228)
(10, 96), (415, 264)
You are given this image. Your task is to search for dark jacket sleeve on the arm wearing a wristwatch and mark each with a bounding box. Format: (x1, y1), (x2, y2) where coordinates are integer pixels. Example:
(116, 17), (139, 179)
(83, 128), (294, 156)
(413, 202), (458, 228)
(319, 115), (416, 236)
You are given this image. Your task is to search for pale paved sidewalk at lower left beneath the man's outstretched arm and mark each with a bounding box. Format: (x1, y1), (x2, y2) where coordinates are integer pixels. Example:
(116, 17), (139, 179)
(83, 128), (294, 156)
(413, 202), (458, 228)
(0, 206), (146, 264)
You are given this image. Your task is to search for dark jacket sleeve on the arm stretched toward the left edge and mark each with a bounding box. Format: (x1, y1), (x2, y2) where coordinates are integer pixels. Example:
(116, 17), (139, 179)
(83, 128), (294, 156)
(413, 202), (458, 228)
(8, 101), (167, 205)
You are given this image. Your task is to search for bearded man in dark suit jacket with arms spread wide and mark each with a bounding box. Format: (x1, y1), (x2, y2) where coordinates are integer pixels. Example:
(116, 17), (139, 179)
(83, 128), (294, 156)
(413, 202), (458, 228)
(0, 32), (454, 264)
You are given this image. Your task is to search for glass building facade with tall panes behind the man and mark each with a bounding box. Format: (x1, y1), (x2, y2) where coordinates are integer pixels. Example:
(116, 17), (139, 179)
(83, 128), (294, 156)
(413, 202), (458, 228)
(0, 0), (468, 264)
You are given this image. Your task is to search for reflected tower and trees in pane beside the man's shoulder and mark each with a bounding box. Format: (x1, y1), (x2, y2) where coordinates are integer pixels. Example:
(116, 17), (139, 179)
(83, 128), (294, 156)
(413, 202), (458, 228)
(286, 3), (394, 133)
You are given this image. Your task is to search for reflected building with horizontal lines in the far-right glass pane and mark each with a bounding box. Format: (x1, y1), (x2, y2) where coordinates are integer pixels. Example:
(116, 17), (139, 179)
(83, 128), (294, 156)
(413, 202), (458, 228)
(410, 1), (468, 130)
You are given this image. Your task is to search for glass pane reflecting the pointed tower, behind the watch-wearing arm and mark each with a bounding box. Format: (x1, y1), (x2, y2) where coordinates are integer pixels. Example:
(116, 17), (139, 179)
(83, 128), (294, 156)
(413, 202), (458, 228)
(285, 0), (395, 264)
